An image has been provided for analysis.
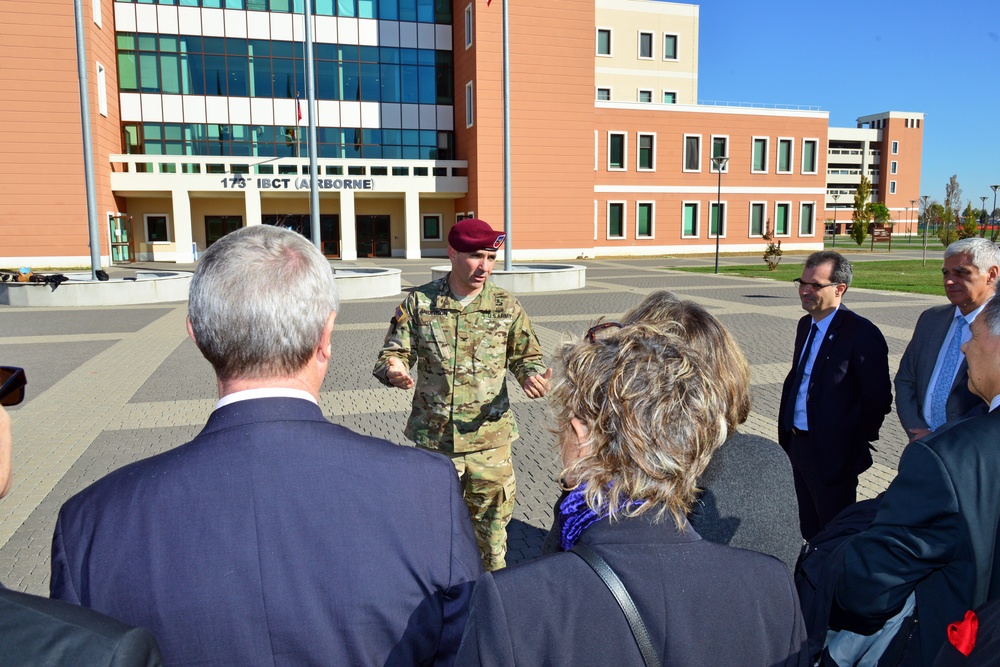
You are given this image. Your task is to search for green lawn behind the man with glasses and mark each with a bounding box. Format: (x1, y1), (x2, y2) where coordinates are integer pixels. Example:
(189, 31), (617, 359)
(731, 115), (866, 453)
(674, 259), (944, 294)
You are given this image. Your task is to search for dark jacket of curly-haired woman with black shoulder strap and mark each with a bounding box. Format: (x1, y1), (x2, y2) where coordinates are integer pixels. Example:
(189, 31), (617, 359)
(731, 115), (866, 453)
(456, 517), (808, 667)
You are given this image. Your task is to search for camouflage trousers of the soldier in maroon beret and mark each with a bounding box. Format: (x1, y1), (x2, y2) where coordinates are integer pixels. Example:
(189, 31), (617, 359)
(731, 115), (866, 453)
(446, 445), (515, 572)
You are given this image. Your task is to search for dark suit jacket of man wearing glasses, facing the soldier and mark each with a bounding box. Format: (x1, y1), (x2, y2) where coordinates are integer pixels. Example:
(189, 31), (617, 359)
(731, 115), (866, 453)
(778, 305), (892, 484)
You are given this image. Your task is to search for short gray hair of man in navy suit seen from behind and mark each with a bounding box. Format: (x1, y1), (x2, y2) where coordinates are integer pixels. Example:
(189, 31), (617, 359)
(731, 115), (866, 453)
(188, 225), (338, 381)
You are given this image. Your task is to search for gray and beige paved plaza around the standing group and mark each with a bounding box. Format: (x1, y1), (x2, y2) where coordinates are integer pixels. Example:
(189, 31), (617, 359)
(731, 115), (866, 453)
(0, 252), (945, 595)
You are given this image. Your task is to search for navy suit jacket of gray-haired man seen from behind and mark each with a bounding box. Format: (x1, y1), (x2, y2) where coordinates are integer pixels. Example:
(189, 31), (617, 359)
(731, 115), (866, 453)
(51, 398), (481, 665)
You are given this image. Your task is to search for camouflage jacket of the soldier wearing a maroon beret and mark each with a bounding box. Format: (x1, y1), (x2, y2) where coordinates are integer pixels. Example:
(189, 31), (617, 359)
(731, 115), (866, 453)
(372, 274), (546, 453)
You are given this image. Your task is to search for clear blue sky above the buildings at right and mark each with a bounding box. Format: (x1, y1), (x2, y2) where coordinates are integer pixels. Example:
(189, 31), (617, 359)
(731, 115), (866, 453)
(694, 0), (1000, 213)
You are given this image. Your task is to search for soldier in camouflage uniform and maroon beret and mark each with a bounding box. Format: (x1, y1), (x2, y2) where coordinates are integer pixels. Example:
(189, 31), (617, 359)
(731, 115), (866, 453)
(373, 219), (552, 571)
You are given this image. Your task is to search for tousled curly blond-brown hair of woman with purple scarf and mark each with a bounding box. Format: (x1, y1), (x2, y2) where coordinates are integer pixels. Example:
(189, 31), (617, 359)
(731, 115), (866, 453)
(550, 322), (727, 525)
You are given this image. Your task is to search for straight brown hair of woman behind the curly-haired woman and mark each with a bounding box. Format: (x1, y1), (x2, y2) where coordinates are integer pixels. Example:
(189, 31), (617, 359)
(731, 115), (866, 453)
(622, 290), (750, 431)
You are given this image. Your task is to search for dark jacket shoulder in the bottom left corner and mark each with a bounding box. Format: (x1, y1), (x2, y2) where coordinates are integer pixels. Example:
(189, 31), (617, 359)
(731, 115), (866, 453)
(0, 586), (163, 667)
